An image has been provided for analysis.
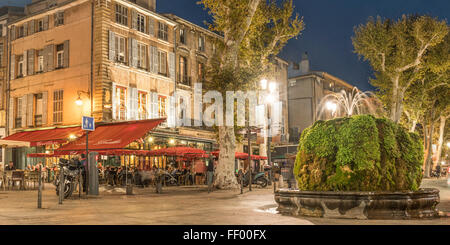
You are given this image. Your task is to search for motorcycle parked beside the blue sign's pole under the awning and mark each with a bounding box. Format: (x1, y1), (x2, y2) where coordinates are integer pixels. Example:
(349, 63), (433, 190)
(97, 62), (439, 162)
(53, 158), (82, 198)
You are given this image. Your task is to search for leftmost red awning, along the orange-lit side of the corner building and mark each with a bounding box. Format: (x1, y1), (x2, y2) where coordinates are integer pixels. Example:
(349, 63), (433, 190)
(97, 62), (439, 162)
(3, 127), (83, 146)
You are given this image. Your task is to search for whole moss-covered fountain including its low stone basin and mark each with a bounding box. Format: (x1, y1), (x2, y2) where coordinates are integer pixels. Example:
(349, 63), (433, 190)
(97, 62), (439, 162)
(275, 115), (439, 219)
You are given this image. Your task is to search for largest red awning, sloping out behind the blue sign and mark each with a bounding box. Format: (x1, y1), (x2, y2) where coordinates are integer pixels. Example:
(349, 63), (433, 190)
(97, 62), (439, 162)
(55, 119), (166, 153)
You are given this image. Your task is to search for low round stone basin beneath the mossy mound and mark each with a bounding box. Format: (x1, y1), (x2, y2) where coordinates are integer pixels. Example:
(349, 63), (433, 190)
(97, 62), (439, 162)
(275, 189), (440, 220)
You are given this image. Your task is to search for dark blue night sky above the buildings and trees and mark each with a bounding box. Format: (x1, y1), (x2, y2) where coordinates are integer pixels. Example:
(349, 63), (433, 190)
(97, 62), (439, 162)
(4, 0), (450, 90)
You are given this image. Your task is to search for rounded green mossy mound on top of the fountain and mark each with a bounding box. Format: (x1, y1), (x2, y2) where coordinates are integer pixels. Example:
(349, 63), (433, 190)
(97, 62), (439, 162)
(294, 115), (423, 191)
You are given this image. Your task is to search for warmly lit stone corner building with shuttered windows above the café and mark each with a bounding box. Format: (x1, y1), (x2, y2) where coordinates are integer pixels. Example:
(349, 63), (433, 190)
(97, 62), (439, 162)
(0, 0), (288, 168)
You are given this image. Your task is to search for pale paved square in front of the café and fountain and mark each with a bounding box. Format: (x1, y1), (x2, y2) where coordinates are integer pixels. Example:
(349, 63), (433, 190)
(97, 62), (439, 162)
(0, 179), (450, 225)
